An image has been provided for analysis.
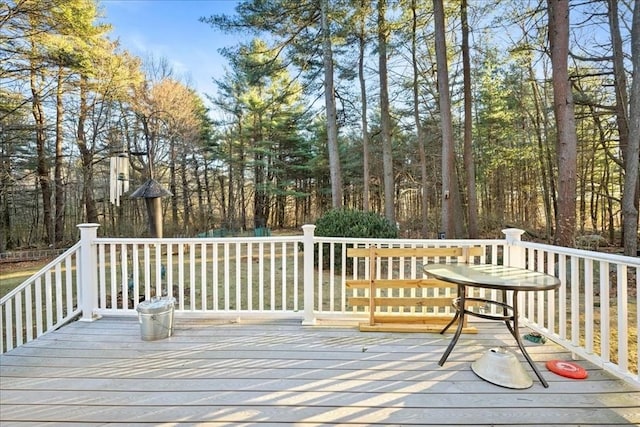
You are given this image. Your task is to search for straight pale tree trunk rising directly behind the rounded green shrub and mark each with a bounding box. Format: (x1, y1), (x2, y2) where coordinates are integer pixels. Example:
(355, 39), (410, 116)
(320, 0), (342, 209)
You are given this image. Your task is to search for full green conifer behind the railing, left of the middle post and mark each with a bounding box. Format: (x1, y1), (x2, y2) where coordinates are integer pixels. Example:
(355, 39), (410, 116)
(211, 39), (308, 228)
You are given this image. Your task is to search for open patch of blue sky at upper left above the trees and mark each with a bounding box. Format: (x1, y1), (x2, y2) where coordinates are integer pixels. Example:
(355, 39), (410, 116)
(100, 0), (240, 100)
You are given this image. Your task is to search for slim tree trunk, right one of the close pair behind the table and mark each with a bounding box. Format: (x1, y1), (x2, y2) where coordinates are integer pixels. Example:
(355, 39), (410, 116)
(460, 0), (478, 239)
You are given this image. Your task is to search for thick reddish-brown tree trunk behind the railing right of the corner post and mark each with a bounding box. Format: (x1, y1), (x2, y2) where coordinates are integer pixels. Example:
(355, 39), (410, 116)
(547, 0), (577, 247)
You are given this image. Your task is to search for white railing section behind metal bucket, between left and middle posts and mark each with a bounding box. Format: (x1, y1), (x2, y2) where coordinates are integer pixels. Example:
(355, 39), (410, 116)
(92, 236), (303, 315)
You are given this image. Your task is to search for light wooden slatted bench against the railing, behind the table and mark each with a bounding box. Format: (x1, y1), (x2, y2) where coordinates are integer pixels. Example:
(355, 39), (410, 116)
(345, 246), (484, 333)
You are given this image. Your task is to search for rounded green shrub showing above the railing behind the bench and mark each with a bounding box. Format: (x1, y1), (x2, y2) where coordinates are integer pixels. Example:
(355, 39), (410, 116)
(315, 209), (398, 239)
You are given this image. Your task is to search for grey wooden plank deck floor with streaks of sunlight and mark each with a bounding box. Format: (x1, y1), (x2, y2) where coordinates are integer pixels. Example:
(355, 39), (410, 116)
(0, 318), (640, 426)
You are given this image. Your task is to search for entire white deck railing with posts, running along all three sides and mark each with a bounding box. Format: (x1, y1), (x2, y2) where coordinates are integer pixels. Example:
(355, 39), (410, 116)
(0, 224), (640, 384)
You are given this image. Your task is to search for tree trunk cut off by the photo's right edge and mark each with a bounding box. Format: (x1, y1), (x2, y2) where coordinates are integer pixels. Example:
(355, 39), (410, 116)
(622, 2), (640, 256)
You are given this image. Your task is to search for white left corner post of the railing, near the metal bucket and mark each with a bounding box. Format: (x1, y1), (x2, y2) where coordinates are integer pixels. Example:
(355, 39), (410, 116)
(78, 223), (100, 322)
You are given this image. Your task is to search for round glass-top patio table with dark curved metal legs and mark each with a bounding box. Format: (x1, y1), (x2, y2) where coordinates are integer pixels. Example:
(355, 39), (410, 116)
(424, 264), (560, 387)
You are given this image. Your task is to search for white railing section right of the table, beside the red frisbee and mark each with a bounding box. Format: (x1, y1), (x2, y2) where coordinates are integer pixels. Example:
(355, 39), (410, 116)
(514, 242), (640, 384)
